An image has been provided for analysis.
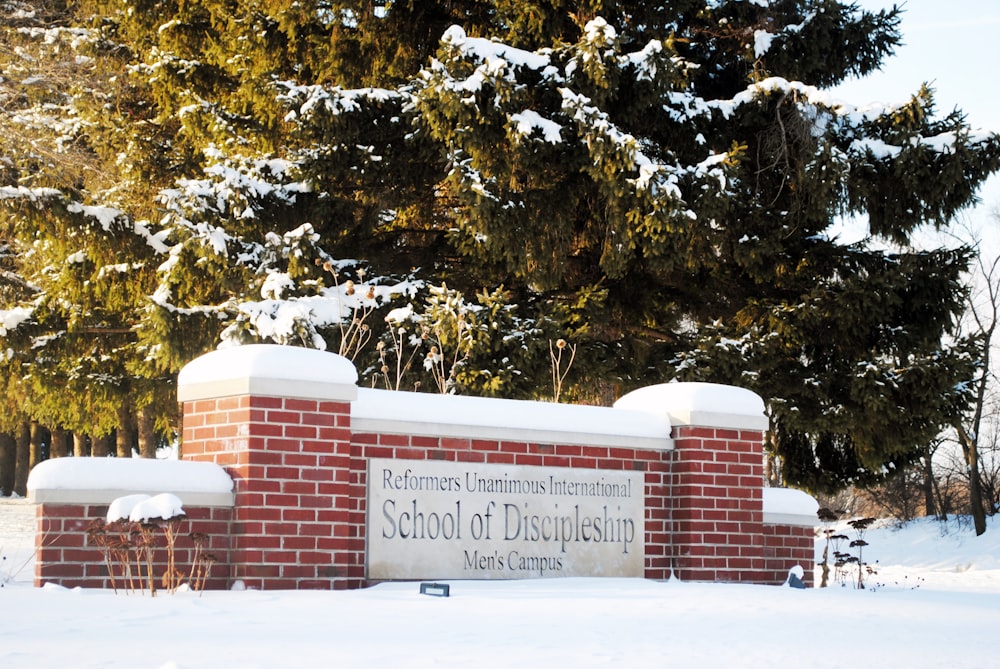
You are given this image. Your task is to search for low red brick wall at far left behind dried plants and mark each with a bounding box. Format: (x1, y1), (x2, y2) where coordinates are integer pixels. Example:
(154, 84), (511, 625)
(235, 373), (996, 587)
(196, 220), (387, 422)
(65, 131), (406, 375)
(35, 504), (232, 589)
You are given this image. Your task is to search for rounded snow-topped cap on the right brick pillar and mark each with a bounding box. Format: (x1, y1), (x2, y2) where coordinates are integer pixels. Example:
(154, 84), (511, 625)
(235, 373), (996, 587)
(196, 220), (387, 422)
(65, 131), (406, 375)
(615, 383), (769, 431)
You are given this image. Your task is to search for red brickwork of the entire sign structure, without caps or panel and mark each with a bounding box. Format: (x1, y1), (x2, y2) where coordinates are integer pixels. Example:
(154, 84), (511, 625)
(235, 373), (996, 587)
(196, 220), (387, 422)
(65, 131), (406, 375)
(37, 396), (813, 589)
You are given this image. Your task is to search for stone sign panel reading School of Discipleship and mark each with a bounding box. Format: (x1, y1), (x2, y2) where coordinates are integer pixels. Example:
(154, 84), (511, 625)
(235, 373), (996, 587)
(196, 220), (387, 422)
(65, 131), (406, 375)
(367, 459), (645, 580)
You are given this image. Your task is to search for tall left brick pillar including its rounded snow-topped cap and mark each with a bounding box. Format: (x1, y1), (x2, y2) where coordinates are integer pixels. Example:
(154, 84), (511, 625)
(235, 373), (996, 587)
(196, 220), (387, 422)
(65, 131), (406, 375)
(177, 345), (364, 589)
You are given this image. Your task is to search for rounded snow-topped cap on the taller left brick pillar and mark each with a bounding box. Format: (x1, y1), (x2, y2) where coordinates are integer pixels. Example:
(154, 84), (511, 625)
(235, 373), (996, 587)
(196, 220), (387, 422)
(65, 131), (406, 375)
(177, 344), (358, 402)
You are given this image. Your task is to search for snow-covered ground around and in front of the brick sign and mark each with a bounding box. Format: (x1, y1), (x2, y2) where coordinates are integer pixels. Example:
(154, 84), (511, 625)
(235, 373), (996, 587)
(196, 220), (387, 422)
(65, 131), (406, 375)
(0, 499), (1000, 669)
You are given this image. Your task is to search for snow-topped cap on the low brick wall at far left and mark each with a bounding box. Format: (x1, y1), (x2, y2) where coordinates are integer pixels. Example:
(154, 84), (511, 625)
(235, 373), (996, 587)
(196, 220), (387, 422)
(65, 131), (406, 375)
(28, 457), (234, 506)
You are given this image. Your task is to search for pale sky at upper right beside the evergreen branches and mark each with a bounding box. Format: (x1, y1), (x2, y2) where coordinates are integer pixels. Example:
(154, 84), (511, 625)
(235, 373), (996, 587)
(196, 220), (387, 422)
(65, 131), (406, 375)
(834, 0), (1000, 235)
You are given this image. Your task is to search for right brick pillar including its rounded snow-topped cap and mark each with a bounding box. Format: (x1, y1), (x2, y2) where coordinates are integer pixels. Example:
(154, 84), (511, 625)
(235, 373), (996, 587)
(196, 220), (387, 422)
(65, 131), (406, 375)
(615, 383), (768, 582)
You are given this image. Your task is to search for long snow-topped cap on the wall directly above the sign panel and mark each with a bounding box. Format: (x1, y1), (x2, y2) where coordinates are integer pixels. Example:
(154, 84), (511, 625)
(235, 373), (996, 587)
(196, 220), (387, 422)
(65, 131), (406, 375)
(351, 388), (673, 450)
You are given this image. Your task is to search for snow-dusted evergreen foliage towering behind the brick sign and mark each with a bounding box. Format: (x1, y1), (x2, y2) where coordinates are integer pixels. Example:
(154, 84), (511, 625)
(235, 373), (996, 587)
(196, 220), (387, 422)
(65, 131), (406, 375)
(4, 0), (1000, 490)
